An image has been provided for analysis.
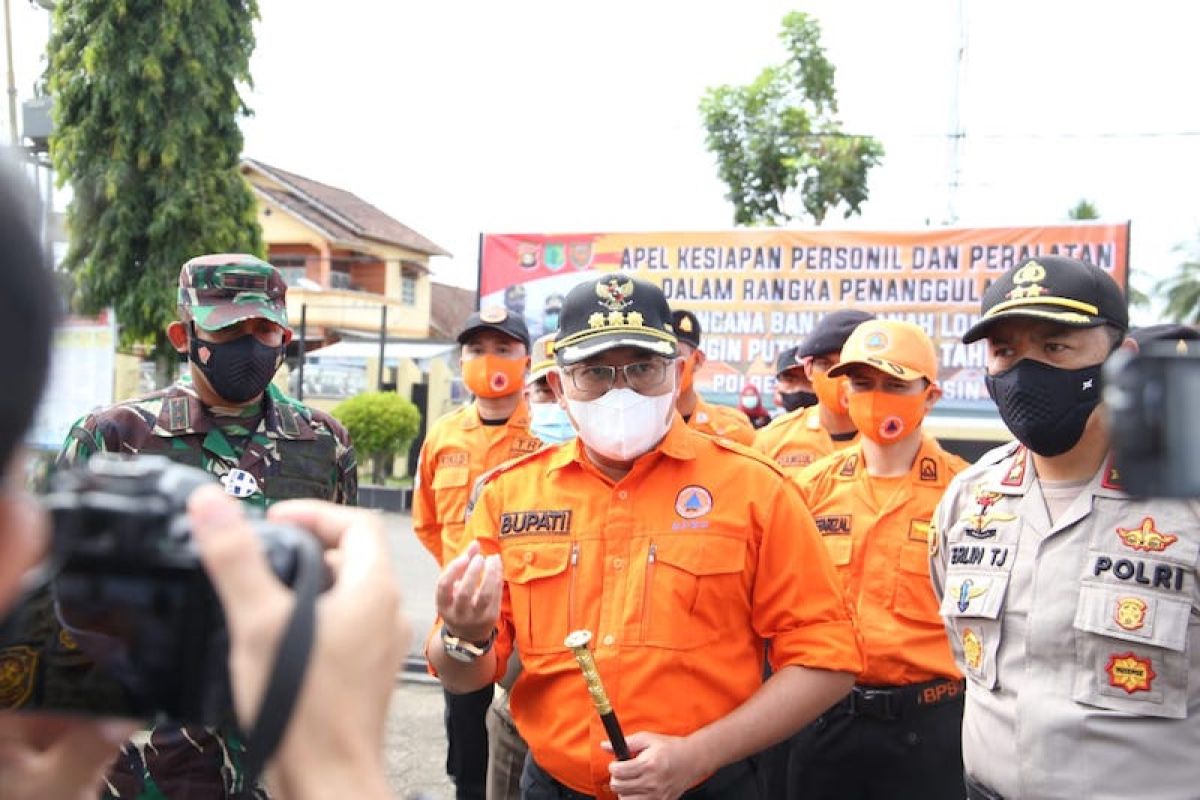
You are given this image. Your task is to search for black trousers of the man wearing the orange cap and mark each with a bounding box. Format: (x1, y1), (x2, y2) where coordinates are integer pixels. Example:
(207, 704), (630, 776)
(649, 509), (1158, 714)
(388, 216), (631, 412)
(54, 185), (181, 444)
(787, 694), (966, 800)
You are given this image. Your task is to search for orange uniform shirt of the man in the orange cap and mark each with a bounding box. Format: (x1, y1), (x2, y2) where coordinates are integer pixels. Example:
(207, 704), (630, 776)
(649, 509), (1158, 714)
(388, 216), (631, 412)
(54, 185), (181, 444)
(792, 435), (967, 686)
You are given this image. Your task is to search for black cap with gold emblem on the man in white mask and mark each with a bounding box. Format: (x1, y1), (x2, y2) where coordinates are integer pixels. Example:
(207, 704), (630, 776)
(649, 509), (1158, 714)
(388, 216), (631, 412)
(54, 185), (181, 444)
(554, 272), (677, 365)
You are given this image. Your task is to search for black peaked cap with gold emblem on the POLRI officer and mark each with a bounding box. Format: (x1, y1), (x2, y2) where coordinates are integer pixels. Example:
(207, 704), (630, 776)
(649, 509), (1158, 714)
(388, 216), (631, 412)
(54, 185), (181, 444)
(962, 255), (1129, 344)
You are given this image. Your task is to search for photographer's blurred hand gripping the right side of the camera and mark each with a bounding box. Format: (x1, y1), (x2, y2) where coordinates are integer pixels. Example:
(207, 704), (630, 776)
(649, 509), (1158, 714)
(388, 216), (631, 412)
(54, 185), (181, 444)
(188, 487), (408, 798)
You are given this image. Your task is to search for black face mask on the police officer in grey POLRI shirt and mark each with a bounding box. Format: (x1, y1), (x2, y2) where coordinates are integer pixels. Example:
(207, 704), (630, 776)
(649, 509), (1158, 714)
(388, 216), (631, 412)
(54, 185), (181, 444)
(984, 359), (1102, 458)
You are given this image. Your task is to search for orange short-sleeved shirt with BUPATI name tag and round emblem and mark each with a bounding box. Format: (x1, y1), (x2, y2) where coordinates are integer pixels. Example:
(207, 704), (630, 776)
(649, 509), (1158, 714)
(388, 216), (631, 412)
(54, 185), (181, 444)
(467, 415), (862, 796)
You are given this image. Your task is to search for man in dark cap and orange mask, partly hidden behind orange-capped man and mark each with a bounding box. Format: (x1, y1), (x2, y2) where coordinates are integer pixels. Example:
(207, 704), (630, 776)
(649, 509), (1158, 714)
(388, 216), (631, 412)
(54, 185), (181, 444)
(754, 309), (875, 475)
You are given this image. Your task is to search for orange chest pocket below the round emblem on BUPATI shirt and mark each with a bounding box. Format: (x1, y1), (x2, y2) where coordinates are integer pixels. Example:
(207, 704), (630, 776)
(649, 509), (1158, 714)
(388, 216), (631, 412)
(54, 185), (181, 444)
(638, 535), (749, 650)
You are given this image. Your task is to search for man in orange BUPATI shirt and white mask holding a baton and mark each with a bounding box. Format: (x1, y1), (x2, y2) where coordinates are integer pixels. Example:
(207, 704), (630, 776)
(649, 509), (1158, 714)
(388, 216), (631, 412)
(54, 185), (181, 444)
(426, 273), (862, 800)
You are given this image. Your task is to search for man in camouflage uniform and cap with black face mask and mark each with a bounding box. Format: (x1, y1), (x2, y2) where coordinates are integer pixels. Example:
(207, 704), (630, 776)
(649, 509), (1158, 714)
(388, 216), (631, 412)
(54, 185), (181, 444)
(59, 254), (358, 800)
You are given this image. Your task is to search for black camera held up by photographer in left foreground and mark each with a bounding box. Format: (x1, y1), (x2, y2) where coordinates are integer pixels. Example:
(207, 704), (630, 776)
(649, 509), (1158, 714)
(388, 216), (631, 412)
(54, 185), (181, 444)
(0, 455), (322, 726)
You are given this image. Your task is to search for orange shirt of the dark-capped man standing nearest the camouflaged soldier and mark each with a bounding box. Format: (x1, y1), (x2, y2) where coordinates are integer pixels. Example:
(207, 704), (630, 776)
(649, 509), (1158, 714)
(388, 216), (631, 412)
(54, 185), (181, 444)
(413, 401), (541, 565)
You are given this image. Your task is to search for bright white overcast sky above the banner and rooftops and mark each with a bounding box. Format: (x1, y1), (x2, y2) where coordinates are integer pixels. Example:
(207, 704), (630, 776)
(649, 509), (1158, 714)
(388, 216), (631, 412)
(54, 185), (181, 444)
(13, 0), (1200, 321)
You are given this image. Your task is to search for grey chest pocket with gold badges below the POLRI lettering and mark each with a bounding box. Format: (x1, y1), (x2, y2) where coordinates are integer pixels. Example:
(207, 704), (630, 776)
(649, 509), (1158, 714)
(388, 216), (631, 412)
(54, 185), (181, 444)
(1073, 584), (1192, 720)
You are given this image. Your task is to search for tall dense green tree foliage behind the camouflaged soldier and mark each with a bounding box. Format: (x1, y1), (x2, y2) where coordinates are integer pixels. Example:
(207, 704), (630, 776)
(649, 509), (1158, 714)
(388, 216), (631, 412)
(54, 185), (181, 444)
(48, 0), (263, 354)
